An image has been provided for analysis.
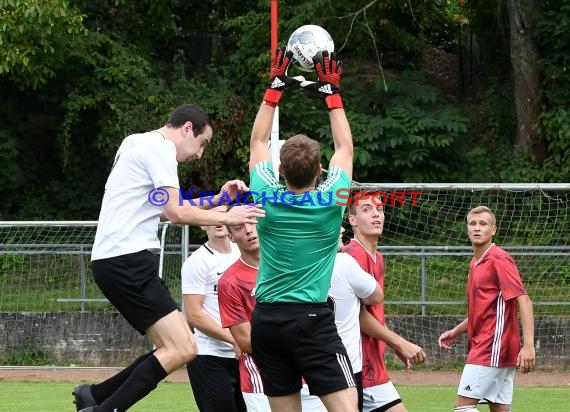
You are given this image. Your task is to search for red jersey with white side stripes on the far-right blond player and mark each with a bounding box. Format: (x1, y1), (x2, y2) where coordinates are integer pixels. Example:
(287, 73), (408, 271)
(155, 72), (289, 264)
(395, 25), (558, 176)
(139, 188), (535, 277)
(467, 243), (526, 368)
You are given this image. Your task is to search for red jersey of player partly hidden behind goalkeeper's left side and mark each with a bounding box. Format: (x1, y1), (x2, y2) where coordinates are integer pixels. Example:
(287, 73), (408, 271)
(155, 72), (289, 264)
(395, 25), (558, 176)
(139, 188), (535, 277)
(218, 258), (263, 393)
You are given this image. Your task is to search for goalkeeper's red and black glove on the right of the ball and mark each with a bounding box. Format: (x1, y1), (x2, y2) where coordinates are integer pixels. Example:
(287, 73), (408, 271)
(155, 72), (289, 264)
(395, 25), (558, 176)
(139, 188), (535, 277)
(301, 50), (343, 110)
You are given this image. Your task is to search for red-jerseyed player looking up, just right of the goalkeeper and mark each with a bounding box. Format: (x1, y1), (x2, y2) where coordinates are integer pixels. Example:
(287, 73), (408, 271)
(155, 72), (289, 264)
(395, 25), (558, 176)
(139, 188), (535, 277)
(343, 193), (426, 412)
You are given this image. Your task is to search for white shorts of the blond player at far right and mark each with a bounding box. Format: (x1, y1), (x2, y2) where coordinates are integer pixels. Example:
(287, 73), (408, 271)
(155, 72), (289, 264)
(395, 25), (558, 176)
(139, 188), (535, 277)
(457, 364), (515, 405)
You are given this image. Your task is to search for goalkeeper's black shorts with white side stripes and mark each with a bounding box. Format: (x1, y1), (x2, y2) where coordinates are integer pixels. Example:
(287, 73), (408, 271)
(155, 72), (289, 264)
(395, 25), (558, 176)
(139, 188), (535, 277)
(251, 303), (356, 396)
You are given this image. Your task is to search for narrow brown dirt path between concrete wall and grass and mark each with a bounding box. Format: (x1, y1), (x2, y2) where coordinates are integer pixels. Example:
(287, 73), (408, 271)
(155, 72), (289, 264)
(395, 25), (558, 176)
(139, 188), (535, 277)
(0, 367), (570, 388)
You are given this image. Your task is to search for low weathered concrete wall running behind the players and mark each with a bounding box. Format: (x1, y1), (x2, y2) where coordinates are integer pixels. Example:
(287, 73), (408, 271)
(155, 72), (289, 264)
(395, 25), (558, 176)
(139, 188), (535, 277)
(0, 312), (570, 370)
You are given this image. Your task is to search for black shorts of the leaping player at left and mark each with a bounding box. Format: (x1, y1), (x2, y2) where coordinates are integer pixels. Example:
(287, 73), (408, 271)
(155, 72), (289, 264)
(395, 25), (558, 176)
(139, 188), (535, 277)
(92, 250), (178, 335)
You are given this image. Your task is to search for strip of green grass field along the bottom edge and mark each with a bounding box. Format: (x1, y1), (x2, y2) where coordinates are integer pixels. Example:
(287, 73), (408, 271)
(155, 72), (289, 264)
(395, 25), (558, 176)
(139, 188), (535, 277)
(0, 381), (570, 412)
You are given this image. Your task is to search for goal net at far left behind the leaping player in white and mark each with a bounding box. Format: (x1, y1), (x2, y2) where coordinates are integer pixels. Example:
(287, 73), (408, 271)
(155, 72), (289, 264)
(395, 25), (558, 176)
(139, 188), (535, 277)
(0, 221), (190, 366)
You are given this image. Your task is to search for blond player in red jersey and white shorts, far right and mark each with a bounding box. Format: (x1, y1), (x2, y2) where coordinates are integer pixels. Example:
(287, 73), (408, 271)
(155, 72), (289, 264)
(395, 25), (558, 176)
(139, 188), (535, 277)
(439, 206), (536, 412)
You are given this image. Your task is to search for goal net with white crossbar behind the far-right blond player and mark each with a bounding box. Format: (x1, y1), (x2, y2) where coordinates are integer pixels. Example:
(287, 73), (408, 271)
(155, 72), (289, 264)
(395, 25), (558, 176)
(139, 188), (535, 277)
(345, 184), (570, 368)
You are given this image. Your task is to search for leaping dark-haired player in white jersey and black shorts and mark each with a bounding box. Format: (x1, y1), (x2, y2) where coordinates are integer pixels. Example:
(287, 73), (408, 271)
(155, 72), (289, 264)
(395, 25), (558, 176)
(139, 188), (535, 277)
(73, 104), (263, 412)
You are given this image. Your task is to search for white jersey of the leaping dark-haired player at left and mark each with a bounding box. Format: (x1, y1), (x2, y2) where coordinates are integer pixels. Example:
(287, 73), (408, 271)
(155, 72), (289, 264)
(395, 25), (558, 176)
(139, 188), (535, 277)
(91, 131), (179, 260)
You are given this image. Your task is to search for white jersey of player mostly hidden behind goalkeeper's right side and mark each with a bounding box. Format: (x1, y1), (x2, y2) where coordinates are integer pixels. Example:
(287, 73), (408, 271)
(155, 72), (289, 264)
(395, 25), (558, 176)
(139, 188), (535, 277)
(329, 253), (376, 373)
